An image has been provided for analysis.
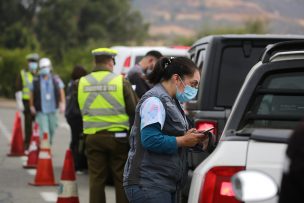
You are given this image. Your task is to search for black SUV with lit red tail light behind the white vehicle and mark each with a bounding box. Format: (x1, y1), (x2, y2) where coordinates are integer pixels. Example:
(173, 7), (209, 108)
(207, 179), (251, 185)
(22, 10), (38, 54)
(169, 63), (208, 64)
(185, 35), (304, 169)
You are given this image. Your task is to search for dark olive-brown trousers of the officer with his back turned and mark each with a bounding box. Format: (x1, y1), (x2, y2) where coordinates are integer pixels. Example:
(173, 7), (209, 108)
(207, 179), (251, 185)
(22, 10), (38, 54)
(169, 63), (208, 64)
(86, 131), (129, 203)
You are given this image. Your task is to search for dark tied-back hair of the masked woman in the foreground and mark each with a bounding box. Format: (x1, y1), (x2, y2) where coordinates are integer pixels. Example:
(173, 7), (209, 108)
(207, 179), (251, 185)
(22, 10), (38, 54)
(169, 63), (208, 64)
(148, 57), (198, 84)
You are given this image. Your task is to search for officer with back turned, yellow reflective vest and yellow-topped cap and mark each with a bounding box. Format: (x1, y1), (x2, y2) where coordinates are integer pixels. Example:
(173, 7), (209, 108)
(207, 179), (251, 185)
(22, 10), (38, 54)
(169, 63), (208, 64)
(78, 48), (137, 203)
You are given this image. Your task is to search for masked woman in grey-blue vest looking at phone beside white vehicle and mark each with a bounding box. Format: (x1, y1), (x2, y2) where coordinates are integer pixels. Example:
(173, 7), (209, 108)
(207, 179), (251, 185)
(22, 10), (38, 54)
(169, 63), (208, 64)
(123, 57), (206, 203)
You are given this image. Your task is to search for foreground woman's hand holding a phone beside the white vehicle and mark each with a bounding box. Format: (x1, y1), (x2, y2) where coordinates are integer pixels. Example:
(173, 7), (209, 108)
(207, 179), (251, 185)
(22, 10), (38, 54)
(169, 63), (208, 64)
(176, 128), (208, 147)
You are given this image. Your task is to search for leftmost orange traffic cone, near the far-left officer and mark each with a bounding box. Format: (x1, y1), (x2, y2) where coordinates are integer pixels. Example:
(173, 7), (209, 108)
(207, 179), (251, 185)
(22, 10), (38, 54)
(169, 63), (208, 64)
(7, 111), (24, 156)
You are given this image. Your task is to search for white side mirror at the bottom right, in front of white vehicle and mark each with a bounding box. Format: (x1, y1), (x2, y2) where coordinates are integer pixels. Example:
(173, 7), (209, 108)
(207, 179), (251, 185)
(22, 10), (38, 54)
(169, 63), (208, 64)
(231, 171), (278, 202)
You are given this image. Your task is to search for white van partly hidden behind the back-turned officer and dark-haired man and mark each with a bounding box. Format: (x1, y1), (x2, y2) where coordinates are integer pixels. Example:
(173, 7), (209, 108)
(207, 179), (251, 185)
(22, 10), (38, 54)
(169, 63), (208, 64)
(111, 46), (189, 75)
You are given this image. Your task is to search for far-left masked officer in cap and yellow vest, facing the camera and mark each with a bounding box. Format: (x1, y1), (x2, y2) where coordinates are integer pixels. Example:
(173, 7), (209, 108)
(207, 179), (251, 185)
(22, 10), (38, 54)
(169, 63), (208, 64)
(15, 53), (39, 150)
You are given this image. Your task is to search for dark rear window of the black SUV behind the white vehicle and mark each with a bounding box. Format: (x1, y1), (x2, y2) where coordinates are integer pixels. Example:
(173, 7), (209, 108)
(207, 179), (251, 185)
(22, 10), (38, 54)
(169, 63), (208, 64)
(216, 46), (264, 108)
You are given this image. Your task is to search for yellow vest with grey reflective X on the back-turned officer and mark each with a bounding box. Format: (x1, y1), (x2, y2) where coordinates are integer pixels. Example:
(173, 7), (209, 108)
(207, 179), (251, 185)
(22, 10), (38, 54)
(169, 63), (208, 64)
(78, 71), (129, 134)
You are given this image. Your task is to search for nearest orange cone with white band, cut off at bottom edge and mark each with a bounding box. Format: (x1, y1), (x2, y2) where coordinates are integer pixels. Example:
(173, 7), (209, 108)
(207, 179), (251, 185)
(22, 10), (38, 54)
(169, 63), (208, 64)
(57, 149), (79, 203)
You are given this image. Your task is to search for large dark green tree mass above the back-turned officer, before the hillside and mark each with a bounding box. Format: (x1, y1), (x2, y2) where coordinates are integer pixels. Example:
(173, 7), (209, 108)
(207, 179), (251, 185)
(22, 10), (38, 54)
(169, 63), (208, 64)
(35, 0), (147, 61)
